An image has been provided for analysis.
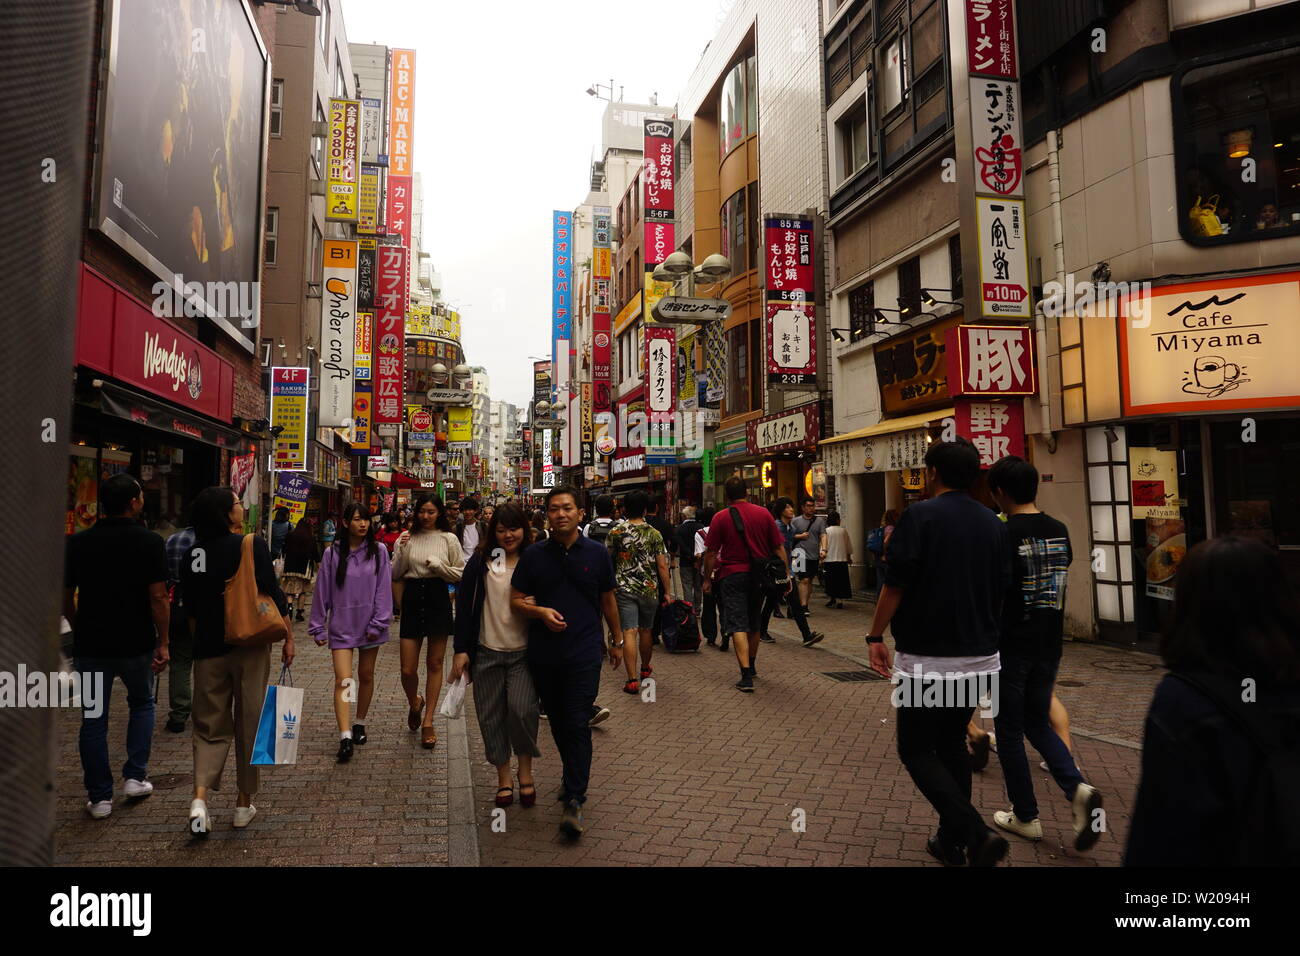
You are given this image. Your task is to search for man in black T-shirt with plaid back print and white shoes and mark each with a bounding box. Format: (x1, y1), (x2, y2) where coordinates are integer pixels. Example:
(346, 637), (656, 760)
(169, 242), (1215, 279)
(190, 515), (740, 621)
(988, 455), (1102, 851)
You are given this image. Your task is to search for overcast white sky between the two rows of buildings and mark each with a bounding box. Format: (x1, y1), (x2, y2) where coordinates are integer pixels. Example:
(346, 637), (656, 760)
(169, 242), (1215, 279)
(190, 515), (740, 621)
(343, 0), (733, 405)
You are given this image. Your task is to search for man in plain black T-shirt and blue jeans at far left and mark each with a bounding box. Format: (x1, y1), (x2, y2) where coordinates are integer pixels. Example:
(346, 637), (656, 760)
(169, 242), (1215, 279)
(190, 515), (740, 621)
(64, 475), (170, 819)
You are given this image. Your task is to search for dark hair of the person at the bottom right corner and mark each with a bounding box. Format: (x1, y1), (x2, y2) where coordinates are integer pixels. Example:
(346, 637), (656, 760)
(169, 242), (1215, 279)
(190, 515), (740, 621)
(1160, 535), (1300, 687)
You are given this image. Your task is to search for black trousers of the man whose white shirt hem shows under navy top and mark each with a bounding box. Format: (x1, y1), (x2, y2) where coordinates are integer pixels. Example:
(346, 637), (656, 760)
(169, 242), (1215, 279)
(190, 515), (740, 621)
(894, 678), (988, 847)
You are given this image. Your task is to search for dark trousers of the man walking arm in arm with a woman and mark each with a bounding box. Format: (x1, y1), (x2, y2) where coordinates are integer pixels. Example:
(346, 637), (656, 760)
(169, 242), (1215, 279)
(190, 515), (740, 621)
(528, 653), (601, 804)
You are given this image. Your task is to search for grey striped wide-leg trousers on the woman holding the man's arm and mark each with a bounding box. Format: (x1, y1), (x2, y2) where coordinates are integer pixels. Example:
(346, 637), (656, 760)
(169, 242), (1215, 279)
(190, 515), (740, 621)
(471, 644), (541, 766)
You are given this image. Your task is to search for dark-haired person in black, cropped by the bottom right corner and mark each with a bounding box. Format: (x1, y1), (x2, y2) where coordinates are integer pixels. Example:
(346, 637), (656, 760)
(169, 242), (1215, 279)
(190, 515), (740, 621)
(1125, 537), (1300, 866)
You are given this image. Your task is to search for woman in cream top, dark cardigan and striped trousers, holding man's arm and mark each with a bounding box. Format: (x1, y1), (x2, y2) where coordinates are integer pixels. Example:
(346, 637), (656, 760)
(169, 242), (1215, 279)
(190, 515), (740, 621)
(451, 505), (541, 806)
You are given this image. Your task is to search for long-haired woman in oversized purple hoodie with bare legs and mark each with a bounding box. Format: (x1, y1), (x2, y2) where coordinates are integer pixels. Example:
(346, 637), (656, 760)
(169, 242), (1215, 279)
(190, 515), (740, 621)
(307, 503), (393, 763)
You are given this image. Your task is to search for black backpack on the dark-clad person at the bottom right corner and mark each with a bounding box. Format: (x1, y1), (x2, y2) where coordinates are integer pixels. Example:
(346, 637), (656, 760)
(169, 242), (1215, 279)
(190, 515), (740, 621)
(1171, 672), (1300, 866)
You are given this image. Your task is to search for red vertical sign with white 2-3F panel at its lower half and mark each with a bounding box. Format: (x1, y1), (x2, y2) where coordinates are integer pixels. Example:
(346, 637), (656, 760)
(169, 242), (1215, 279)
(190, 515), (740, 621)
(763, 216), (816, 385)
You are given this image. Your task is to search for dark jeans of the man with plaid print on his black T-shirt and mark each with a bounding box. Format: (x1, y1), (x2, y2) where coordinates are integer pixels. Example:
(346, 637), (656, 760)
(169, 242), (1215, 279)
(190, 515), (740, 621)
(993, 650), (1083, 823)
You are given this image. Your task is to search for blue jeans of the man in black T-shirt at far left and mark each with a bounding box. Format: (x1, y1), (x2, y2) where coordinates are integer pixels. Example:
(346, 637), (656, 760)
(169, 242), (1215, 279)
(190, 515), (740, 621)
(74, 652), (153, 803)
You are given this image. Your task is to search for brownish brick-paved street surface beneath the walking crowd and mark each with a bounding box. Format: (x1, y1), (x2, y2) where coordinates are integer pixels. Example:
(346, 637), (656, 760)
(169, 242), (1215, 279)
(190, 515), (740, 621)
(56, 587), (1161, 866)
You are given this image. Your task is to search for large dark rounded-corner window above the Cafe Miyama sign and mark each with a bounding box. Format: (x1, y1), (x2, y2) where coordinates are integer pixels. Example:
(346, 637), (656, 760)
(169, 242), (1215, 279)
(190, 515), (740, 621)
(1173, 47), (1300, 246)
